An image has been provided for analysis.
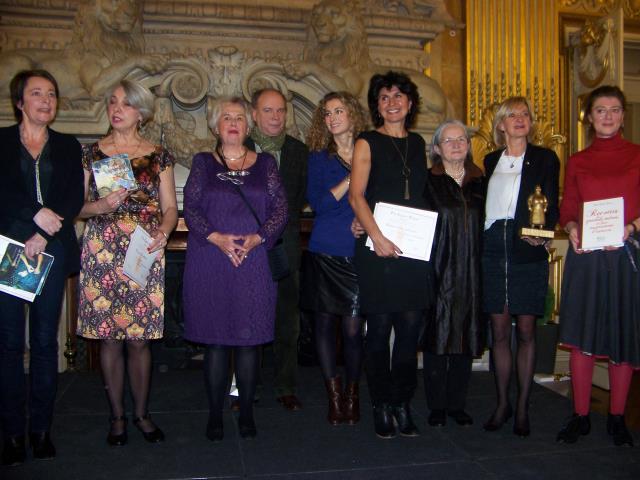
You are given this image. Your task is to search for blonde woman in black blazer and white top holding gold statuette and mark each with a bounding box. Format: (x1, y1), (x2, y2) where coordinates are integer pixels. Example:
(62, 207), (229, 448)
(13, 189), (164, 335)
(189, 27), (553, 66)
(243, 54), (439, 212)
(482, 97), (560, 437)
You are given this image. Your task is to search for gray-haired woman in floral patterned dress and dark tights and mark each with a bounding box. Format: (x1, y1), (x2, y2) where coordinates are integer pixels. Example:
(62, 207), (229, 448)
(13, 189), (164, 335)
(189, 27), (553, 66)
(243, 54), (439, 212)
(78, 80), (178, 446)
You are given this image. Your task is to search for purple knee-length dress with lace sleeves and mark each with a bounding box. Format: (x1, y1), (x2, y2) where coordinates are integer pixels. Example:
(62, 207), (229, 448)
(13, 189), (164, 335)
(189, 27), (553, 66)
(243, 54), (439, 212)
(183, 152), (287, 346)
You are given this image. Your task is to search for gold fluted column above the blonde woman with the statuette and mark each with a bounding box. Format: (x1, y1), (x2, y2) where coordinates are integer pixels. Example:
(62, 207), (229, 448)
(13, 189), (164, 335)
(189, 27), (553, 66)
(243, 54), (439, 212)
(466, 0), (561, 131)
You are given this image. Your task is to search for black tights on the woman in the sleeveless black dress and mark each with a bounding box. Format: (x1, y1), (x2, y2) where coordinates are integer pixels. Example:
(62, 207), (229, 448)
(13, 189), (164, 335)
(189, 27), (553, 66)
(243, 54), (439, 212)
(365, 310), (424, 405)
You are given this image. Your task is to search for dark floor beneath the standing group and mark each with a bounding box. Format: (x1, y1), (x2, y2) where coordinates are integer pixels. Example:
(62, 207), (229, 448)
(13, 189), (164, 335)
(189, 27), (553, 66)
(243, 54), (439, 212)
(0, 356), (640, 480)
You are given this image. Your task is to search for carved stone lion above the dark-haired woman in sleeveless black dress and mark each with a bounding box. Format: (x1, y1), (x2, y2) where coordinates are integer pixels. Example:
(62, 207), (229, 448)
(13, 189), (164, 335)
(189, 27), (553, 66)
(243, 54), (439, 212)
(284, 0), (447, 117)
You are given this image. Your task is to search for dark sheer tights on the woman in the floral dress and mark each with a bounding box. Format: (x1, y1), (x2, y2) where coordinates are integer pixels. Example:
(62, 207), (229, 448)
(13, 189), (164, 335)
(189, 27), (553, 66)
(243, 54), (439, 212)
(100, 340), (155, 434)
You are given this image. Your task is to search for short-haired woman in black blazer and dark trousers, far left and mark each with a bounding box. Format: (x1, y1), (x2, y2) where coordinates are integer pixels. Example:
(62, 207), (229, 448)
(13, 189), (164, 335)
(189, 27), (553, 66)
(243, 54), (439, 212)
(0, 70), (84, 465)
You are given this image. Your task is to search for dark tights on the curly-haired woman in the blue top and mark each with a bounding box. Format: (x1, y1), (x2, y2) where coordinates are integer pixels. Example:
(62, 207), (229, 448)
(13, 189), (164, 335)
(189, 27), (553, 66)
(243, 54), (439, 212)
(314, 312), (362, 383)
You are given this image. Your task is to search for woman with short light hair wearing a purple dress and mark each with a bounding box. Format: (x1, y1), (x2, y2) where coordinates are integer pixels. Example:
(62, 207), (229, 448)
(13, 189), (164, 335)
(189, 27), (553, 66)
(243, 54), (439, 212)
(183, 97), (287, 441)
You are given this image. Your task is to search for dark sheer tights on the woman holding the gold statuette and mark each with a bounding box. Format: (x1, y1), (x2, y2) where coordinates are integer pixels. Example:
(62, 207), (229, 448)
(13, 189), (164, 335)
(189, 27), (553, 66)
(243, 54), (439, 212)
(491, 307), (536, 421)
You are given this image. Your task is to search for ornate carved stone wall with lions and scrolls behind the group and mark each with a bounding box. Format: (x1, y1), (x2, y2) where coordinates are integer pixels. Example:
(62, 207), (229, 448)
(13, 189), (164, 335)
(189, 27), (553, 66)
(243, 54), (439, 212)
(0, 0), (461, 166)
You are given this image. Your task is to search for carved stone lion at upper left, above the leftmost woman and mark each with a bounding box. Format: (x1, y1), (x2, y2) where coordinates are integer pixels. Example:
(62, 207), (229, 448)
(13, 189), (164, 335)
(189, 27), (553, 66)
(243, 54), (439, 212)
(0, 0), (166, 108)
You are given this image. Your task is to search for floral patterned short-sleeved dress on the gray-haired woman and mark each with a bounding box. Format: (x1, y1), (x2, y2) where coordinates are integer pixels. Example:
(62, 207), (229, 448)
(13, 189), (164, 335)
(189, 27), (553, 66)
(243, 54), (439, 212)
(77, 143), (174, 340)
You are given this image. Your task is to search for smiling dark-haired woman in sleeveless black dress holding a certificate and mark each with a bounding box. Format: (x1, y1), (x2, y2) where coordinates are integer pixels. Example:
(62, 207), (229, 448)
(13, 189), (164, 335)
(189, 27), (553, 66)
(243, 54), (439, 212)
(349, 71), (433, 438)
